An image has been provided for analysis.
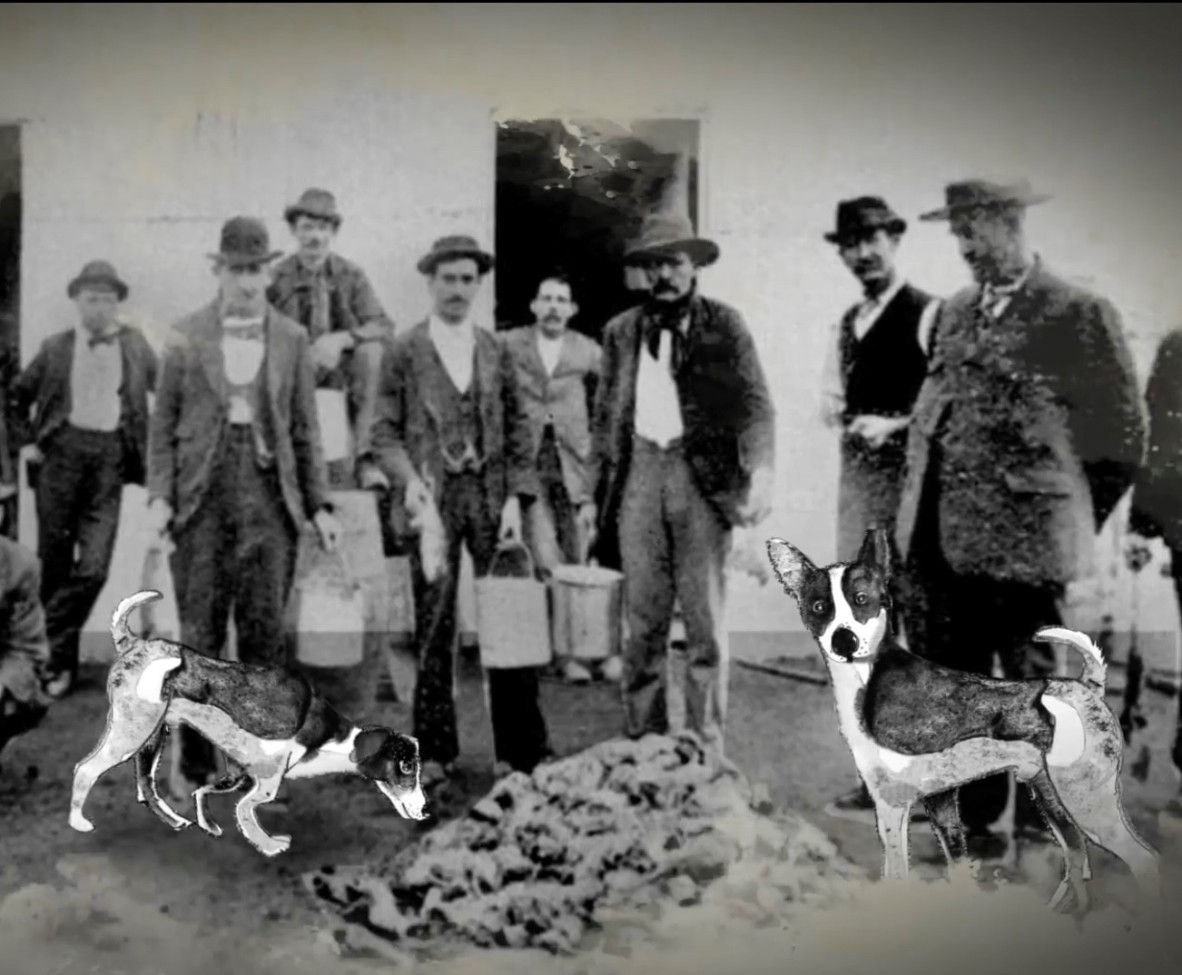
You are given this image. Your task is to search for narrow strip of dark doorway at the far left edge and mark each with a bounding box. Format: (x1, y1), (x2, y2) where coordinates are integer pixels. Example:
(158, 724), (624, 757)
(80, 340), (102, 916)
(0, 125), (21, 539)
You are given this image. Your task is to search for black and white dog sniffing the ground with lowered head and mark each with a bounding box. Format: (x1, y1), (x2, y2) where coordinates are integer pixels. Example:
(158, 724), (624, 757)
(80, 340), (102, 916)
(70, 590), (426, 857)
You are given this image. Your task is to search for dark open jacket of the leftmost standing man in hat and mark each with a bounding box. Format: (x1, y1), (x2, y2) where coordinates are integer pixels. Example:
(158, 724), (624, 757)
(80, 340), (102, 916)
(9, 325), (158, 485)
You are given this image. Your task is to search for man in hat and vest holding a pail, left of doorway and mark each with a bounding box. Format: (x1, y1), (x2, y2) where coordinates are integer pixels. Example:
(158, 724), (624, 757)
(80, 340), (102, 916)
(361, 235), (548, 786)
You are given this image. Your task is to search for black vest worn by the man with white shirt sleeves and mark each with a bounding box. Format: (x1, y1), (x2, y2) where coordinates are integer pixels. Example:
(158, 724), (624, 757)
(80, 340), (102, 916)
(840, 284), (931, 417)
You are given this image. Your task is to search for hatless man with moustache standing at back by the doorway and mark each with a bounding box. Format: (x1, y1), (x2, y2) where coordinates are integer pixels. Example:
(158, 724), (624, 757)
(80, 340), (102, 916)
(505, 275), (603, 683)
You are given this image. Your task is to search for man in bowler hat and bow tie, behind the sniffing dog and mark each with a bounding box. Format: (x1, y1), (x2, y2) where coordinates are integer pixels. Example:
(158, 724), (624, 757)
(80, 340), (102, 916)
(148, 216), (339, 798)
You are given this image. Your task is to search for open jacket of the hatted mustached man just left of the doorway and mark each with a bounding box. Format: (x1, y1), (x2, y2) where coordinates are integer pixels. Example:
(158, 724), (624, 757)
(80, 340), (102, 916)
(361, 321), (537, 531)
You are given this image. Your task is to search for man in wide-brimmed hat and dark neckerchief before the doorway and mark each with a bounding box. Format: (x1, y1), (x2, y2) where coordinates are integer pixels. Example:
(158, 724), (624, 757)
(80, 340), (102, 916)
(593, 214), (775, 748)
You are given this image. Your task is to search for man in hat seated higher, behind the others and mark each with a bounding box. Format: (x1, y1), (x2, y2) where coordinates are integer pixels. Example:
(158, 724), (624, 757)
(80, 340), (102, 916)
(267, 188), (394, 487)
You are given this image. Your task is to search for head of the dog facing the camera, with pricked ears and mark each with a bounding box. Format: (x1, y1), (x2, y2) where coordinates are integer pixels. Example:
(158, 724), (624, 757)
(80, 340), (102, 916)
(767, 528), (890, 663)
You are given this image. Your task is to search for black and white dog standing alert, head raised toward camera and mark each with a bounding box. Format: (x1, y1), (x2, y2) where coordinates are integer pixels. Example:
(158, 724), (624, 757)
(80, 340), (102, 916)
(767, 529), (1160, 911)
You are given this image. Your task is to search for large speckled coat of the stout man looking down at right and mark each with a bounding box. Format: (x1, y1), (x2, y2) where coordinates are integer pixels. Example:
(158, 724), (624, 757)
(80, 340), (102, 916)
(896, 262), (1144, 585)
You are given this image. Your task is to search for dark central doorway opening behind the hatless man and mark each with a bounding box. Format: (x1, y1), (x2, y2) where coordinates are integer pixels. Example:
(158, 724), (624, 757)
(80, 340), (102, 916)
(496, 118), (700, 339)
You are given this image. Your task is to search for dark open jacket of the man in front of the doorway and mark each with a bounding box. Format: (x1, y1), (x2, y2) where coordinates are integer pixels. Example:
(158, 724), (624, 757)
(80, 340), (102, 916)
(592, 295), (775, 565)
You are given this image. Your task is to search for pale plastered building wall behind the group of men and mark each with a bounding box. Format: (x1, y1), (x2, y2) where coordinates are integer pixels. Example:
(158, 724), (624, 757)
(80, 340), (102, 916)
(0, 5), (1182, 652)
